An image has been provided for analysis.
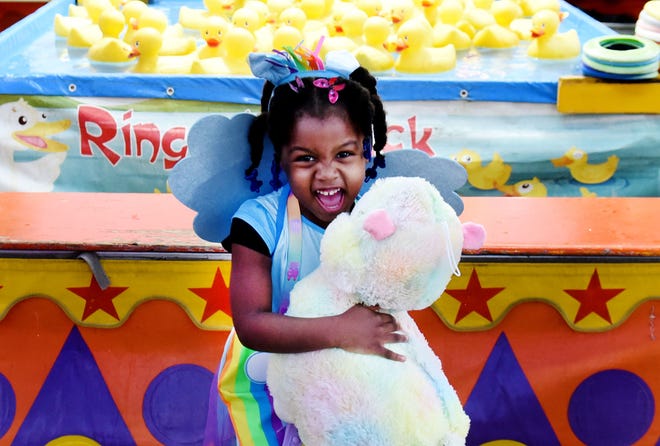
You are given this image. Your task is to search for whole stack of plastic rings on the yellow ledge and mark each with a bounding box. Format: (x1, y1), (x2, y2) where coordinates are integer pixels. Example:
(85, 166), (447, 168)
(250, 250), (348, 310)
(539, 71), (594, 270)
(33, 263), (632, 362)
(582, 35), (660, 80)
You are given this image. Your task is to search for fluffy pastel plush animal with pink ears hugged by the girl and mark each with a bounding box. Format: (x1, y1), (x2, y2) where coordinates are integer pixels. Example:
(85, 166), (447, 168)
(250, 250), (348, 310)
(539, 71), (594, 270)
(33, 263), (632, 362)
(267, 177), (485, 446)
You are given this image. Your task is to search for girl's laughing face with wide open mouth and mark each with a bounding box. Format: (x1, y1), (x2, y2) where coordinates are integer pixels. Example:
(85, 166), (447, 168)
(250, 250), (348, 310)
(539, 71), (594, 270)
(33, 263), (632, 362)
(281, 115), (367, 228)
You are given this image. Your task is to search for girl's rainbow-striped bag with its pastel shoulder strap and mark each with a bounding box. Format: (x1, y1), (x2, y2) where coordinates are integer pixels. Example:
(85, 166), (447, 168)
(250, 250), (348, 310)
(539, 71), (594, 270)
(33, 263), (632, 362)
(218, 193), (302, 446)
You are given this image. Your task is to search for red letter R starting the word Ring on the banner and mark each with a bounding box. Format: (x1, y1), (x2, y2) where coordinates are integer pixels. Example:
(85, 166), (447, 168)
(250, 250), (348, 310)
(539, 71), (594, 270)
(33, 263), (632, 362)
(78, 105), (121, 166)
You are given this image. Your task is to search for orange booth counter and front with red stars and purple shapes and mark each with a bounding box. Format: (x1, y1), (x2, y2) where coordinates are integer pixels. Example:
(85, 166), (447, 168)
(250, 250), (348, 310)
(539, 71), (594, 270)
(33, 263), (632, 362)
(0, 193), (660, 445)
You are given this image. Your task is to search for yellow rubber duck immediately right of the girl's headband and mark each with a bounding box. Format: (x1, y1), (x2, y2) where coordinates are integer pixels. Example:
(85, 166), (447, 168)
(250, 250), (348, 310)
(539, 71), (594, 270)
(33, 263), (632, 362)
(353, 16), (394, 73)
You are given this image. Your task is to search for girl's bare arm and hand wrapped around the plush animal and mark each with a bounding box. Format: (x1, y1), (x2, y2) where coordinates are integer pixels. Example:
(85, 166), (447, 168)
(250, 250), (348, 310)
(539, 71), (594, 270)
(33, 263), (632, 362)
(229, 243), (406, 361)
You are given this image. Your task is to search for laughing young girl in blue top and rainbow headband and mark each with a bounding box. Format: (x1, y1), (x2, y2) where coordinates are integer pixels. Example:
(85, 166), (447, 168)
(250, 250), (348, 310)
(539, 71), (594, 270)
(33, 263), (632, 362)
(211, 48), (405, 445)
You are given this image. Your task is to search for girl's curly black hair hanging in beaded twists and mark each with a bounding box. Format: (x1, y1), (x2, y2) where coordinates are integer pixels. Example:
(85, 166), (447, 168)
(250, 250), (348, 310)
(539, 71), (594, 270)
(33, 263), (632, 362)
(245, 67), (387, 189)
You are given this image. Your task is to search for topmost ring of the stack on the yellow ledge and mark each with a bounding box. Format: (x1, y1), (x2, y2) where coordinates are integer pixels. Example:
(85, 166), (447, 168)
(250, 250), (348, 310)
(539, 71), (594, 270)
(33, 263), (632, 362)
(583, 35), (660, 64)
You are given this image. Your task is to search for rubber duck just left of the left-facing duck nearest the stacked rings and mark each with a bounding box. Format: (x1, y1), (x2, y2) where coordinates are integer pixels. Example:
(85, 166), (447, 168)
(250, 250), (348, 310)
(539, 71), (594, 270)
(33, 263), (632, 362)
(472, 0), (522, 49)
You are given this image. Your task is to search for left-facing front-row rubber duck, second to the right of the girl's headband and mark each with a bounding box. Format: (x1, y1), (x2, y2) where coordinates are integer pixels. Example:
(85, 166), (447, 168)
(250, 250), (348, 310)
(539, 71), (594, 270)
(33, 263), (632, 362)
(394, 19), (456, 74)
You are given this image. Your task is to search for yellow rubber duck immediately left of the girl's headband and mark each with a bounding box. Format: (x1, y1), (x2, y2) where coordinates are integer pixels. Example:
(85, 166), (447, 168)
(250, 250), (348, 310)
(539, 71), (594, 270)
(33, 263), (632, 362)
(190, 26), (256, 75)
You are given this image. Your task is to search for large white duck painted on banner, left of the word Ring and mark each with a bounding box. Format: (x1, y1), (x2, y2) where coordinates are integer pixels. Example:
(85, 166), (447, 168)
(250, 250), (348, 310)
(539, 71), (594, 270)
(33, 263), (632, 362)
(0, 98), (71, 192)
